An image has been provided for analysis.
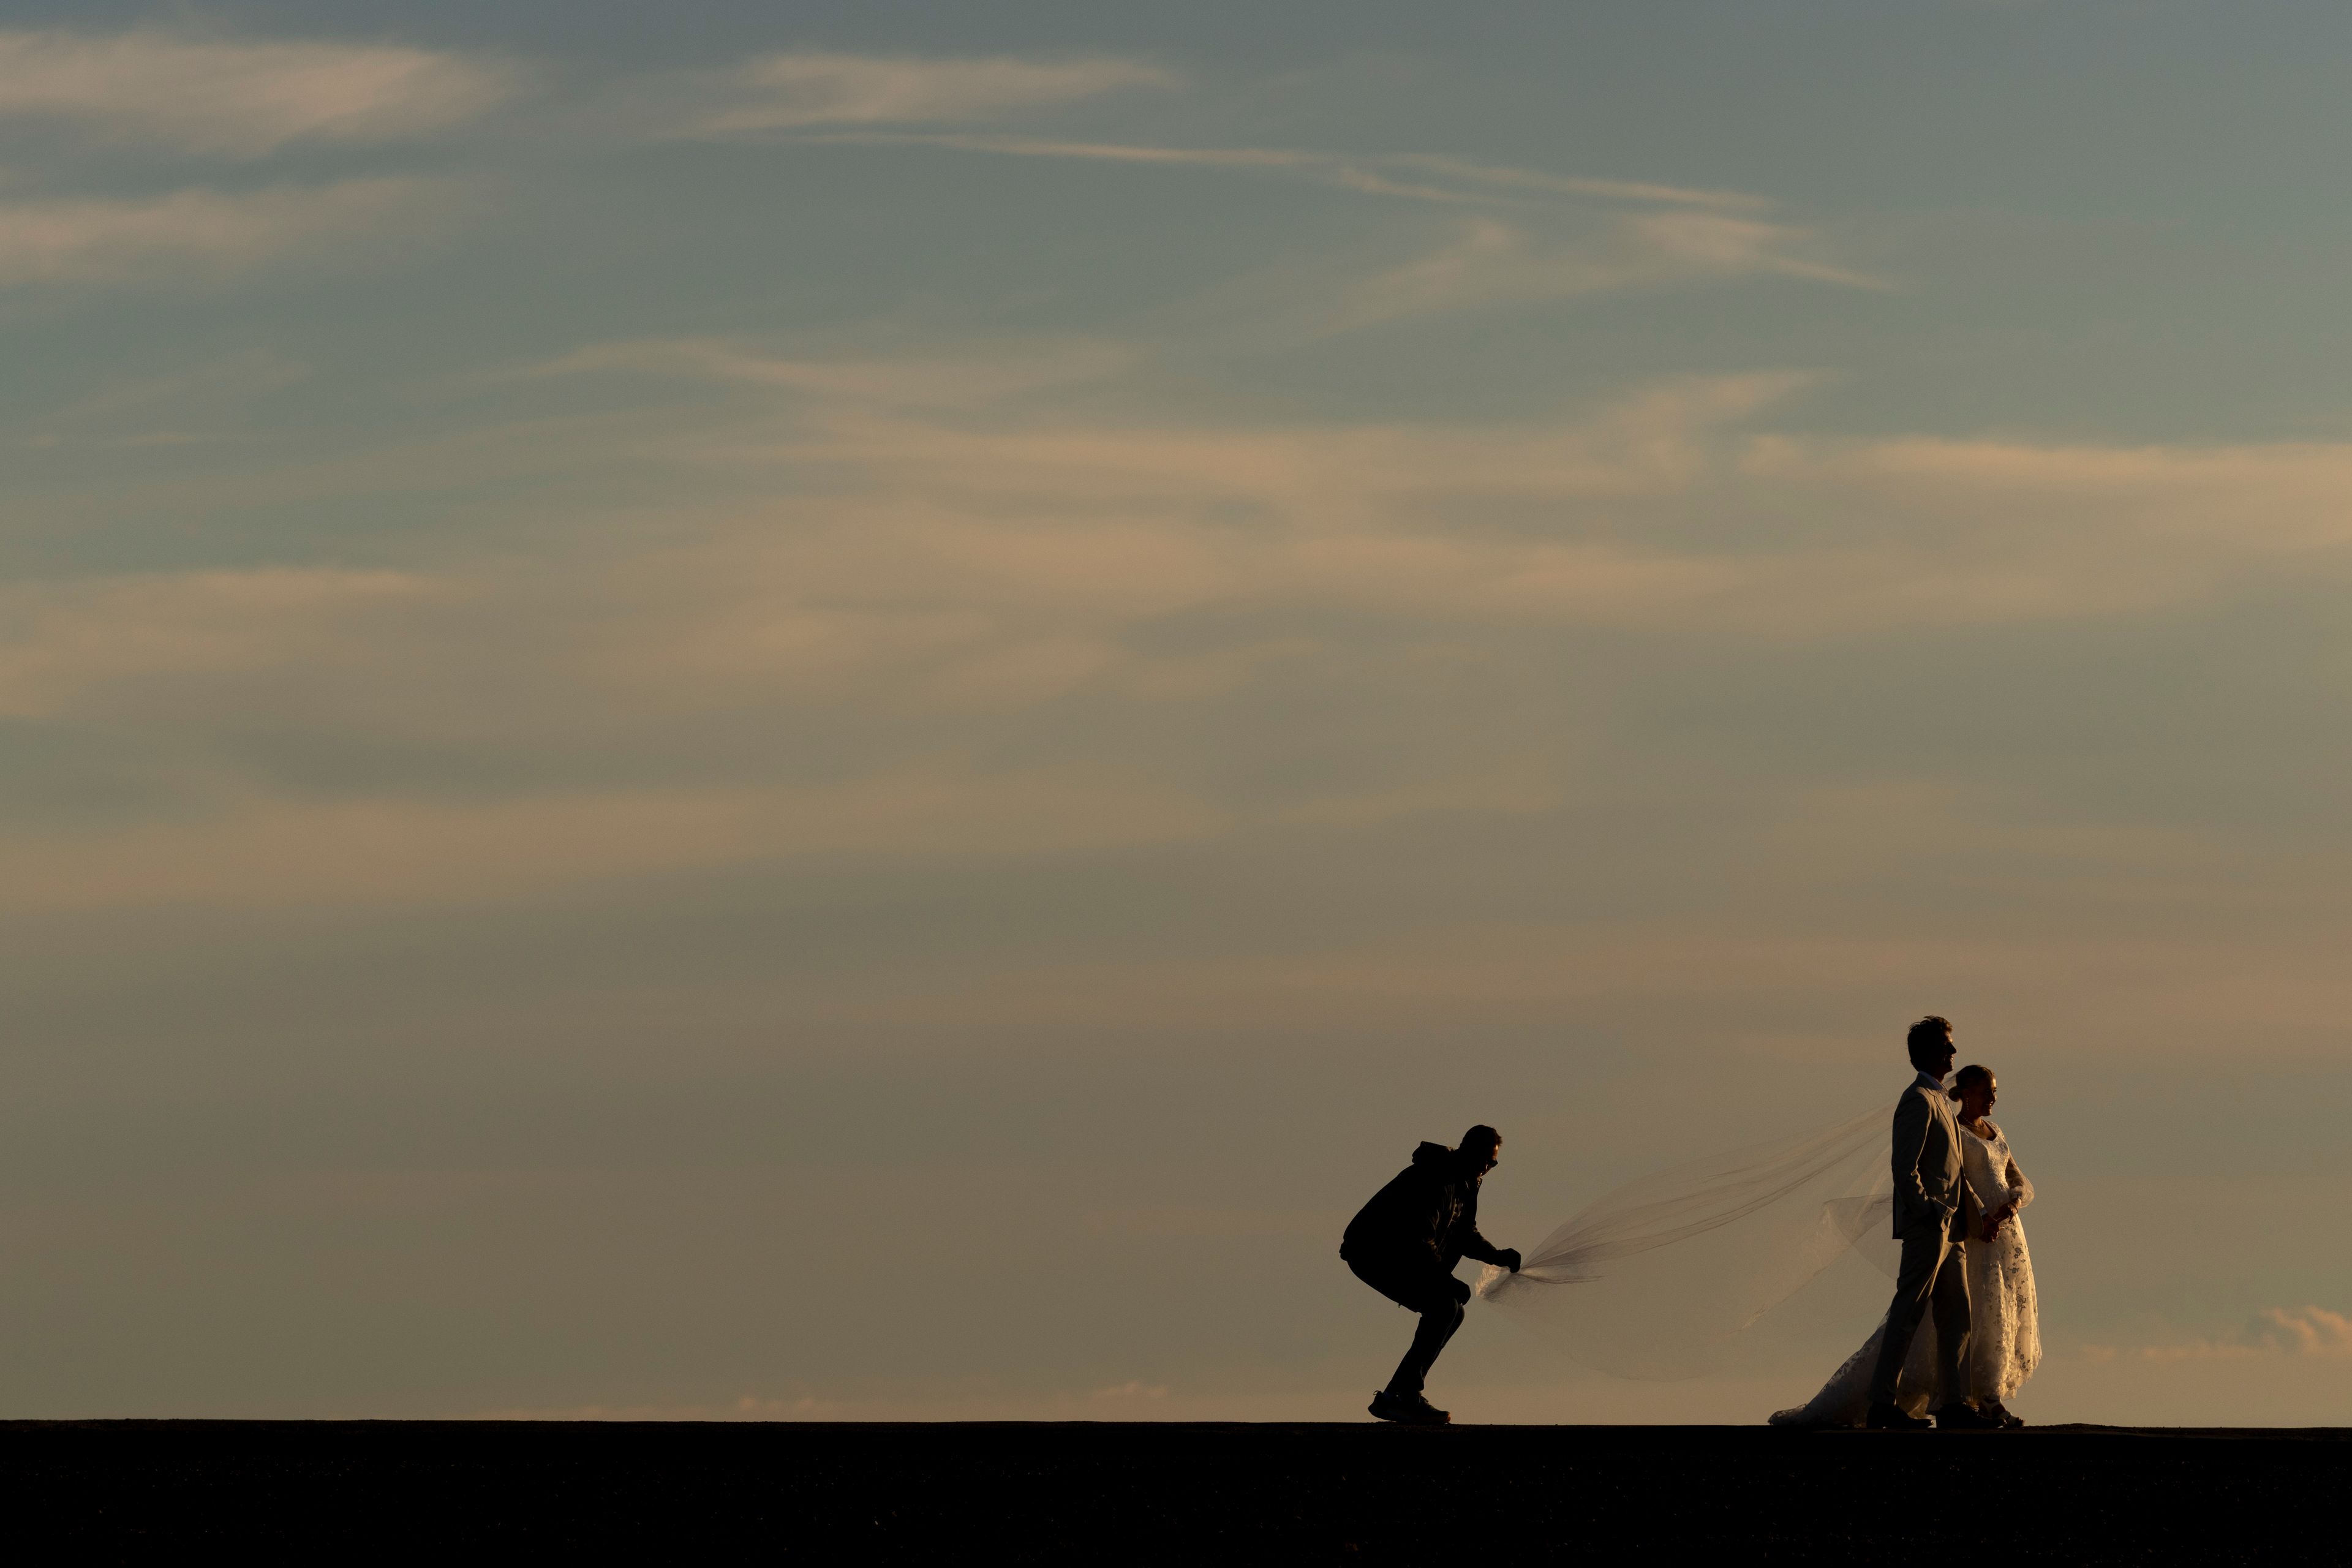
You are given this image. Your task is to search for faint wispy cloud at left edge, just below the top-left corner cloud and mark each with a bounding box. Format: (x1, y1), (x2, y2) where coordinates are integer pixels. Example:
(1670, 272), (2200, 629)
(0, 176), (456, 287)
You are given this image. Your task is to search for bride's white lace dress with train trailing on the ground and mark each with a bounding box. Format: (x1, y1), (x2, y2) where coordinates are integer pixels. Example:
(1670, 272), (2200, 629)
(1771, 1121), (2041, 1427)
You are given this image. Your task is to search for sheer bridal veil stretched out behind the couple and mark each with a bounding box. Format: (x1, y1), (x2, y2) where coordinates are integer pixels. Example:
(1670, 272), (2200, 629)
(1479, 1105), (1896, 1378)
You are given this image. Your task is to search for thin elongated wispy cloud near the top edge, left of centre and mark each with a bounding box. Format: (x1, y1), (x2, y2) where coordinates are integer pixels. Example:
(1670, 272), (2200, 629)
(689, 51), (1176, 137)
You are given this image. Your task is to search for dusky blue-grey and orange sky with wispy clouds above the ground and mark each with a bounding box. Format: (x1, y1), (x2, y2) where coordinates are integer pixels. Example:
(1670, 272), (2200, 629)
(0, 0), (2352, 1425)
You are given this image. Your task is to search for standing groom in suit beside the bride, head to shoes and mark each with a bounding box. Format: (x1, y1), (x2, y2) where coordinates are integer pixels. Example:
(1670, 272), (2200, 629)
(1868, 1018), (2002, 1431)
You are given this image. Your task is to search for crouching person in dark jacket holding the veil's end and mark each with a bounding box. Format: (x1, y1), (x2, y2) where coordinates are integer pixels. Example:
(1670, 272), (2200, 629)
(1338, 1126), (1520, 1427)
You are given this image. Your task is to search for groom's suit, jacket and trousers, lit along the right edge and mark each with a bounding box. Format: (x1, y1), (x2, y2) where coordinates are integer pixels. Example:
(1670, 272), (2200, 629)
(1870, 1072), (1969, 1406)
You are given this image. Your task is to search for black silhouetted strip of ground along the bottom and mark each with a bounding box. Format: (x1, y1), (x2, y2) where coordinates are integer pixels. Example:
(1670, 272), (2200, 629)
(0, 1422), (2352, 1566)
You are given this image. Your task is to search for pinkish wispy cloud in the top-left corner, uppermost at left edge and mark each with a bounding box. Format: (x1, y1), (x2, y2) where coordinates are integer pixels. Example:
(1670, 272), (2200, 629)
(0, 31), (518, 157)
